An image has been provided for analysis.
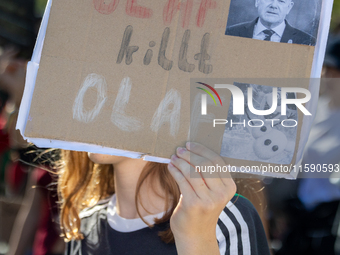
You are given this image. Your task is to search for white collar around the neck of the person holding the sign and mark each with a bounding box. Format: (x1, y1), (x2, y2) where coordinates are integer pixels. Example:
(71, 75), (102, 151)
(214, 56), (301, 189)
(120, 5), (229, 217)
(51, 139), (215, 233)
(107, 194), (164, 233)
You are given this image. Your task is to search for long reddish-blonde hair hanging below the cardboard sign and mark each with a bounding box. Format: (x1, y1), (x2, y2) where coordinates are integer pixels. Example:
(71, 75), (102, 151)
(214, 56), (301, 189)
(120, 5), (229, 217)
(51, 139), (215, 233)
(58, 151), (180, 243)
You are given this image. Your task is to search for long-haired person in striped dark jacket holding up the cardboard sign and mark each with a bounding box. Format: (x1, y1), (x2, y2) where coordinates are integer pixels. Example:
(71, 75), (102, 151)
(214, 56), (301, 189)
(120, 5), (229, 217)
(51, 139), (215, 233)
(59, 143), (270, 255)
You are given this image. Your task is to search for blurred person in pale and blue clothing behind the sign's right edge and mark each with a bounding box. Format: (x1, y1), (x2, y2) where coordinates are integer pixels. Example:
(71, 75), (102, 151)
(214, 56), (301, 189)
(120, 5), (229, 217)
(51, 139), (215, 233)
(276, 37), (340, 255)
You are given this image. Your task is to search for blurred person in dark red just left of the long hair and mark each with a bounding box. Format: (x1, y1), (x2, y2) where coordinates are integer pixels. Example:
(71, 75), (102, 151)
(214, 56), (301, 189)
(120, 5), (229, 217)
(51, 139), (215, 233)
(7, 157), (65, 255)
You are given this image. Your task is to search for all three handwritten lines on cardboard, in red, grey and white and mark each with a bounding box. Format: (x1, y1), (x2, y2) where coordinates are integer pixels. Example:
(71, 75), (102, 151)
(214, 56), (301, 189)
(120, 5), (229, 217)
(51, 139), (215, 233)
(73, 0), (217, 137)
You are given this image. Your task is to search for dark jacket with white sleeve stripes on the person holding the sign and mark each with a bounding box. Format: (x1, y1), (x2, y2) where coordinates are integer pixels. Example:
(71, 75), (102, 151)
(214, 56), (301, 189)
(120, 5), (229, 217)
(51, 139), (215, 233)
(65, 195), (270, 255)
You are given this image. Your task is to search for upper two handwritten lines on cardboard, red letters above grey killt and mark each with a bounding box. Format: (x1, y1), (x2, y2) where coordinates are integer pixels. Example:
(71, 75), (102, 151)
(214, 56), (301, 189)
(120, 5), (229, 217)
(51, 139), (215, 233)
(93, 0), (217, 74)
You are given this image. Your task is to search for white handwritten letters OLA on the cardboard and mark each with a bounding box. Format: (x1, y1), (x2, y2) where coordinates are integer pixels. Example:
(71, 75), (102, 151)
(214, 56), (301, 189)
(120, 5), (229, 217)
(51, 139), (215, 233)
(73, 73), (183, 137)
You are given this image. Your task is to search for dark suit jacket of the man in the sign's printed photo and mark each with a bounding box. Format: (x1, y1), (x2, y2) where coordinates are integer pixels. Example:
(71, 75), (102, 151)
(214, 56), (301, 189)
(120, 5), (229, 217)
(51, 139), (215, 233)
(225, 18), (316, 46)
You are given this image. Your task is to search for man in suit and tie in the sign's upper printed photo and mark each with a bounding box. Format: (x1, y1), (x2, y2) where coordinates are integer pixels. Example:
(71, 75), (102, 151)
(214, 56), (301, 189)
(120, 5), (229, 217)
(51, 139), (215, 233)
(225, 0), (316, 46)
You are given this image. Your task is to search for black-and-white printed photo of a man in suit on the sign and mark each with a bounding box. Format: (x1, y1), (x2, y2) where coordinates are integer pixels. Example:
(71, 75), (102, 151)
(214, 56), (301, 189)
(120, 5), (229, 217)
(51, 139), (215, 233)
(225, 0), (321, 46)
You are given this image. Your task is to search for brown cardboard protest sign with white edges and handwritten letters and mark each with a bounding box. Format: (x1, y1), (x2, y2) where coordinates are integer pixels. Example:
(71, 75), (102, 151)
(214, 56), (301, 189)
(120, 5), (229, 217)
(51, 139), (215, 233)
(17, 0), (332, 177)
